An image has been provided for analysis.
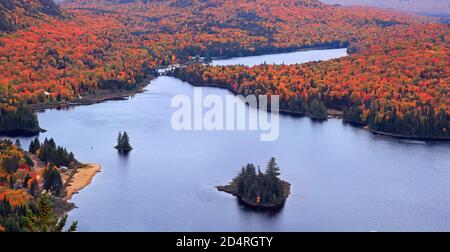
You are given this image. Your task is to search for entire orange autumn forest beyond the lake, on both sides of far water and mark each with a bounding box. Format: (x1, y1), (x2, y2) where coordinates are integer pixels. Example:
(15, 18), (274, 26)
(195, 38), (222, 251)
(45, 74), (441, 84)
(0, 0), (449, 136)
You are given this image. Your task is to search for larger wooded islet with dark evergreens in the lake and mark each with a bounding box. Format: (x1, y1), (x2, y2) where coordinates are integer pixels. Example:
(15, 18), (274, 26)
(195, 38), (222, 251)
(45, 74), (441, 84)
(216, 157), (291, 209)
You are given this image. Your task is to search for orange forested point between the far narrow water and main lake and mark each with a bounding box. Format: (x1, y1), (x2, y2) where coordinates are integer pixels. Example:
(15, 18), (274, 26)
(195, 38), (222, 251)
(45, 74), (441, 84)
(174, 24), (450, 137)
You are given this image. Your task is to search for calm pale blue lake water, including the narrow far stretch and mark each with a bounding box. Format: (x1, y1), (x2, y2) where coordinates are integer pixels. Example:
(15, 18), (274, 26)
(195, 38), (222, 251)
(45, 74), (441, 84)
(12, 49), (450, 231)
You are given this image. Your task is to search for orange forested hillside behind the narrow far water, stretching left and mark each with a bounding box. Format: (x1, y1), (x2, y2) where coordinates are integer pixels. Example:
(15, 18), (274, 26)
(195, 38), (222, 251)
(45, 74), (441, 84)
(0, 0), (422, 104)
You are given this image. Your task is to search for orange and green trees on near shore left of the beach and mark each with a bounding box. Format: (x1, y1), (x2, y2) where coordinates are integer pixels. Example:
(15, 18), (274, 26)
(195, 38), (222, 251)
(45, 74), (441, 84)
(0, 140), (77, 232)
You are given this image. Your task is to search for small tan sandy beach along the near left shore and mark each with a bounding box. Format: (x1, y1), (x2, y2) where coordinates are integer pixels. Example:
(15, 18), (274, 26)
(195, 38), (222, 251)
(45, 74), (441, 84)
(64, 164), (102, 200)
